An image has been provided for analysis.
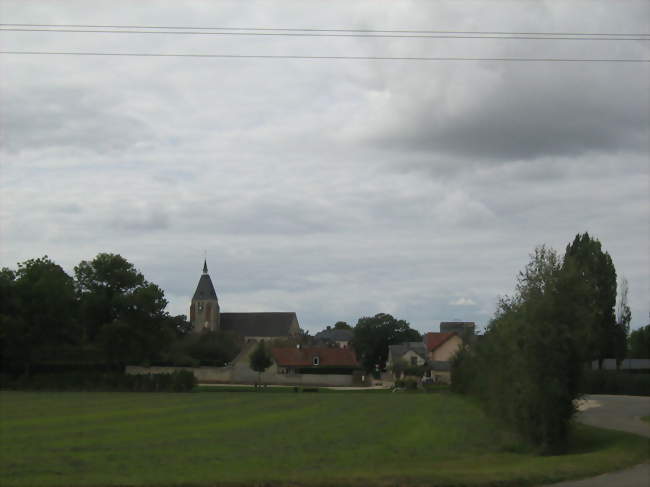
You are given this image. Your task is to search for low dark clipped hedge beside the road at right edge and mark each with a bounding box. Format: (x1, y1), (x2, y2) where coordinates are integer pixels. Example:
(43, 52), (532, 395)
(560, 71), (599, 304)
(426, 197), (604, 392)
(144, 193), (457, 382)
(580, 370), (650, 396)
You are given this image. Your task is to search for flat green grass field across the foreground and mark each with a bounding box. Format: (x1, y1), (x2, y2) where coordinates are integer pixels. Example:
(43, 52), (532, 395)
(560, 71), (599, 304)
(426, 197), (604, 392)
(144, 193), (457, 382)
(0, 392), (648, 487)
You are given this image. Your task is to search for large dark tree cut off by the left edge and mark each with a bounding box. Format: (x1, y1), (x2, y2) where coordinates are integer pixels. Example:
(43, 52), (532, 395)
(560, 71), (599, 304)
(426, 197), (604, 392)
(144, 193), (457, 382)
(0, 256), (79, 374)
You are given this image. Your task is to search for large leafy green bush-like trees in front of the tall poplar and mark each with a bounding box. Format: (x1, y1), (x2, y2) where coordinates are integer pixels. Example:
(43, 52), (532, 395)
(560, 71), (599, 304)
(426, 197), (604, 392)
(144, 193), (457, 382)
(451, 246), (591, 453)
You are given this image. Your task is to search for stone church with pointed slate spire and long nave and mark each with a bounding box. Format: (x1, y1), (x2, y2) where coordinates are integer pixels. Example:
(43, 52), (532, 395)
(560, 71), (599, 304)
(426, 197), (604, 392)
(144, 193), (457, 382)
(190, 261), (300, 342)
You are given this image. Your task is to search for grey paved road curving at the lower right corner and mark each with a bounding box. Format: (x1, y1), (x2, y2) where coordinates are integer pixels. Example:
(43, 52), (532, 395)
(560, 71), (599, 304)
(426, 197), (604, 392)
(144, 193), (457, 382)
(548, 395), (650, 487)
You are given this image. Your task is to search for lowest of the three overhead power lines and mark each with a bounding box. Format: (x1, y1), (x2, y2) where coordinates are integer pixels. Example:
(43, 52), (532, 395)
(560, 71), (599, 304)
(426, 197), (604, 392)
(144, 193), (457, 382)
(0, 51), (650, 63)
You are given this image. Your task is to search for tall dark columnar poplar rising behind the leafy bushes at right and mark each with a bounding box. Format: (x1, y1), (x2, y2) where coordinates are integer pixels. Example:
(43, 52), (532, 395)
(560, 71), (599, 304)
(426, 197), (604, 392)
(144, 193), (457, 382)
(563, 232), (617, 368)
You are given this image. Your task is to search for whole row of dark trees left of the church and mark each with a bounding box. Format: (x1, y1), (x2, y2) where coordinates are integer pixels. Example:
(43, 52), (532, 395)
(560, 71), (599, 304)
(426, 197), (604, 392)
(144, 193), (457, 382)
(0, 253), (240, 375)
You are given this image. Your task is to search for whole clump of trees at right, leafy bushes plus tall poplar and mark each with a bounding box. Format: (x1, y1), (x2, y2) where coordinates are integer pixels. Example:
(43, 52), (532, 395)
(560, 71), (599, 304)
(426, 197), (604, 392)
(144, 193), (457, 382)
(452, 233), (631, 453)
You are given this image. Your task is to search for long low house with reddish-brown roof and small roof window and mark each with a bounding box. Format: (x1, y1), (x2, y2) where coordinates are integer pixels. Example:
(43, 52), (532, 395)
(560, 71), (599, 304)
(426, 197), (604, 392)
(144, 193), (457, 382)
(271, 347), (361, 375)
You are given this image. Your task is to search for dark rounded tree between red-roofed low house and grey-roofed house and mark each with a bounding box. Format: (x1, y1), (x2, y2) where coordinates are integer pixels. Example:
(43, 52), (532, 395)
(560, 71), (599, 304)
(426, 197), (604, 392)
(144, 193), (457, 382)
(352, 313), (422, 372)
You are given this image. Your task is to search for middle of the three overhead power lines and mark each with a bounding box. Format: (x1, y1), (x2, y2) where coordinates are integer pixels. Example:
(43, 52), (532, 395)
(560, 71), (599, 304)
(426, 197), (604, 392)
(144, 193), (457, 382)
(0, 24), (650, 41)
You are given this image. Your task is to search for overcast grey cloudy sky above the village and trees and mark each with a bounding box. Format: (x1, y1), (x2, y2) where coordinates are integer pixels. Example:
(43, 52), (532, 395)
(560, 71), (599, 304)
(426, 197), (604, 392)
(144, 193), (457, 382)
(0, 0), (650, 332)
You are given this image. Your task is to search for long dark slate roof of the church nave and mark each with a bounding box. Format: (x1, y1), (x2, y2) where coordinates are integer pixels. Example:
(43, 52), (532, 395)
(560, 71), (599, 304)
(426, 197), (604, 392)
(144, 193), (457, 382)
(220, 312), (298, 337)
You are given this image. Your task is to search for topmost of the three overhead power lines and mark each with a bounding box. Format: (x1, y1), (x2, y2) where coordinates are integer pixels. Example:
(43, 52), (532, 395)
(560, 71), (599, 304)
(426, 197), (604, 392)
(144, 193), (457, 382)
(0, 23), (650, 37)
